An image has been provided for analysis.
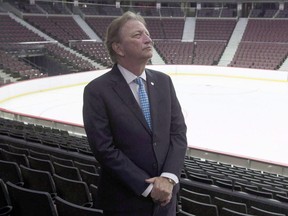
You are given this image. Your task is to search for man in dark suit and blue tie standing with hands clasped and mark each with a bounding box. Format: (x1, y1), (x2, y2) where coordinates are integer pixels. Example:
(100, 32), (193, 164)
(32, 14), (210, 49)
(83, 12), (187, 216)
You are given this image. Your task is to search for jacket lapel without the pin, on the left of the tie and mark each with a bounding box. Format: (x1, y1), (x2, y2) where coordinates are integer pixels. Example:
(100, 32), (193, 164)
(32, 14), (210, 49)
(112, 66), (151, 133)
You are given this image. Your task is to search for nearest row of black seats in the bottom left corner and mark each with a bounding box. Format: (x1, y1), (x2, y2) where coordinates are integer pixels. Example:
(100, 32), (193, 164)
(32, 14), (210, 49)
(0, 179), (103, 216)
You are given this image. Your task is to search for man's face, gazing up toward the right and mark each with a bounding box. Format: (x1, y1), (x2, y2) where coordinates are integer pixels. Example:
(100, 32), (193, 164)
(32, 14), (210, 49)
(118, 20), (153, 62)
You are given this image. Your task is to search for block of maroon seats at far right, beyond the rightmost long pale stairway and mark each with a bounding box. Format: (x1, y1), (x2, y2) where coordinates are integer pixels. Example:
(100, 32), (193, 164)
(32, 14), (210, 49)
(229, 19), (288, 70)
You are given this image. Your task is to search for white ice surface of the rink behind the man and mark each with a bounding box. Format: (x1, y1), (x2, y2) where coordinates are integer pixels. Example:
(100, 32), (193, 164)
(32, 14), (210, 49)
(0, 65), (288, 165)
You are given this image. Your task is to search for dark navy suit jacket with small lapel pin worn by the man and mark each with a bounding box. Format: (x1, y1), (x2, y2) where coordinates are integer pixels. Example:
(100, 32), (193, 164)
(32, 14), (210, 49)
(83, 65), (187, 215)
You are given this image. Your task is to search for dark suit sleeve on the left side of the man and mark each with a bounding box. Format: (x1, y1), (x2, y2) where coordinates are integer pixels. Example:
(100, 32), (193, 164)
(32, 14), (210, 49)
(83, 86), (149, 195)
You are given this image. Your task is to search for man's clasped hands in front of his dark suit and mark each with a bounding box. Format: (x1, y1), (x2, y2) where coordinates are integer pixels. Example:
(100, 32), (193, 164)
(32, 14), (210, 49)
(146, 176), (173, 206)
